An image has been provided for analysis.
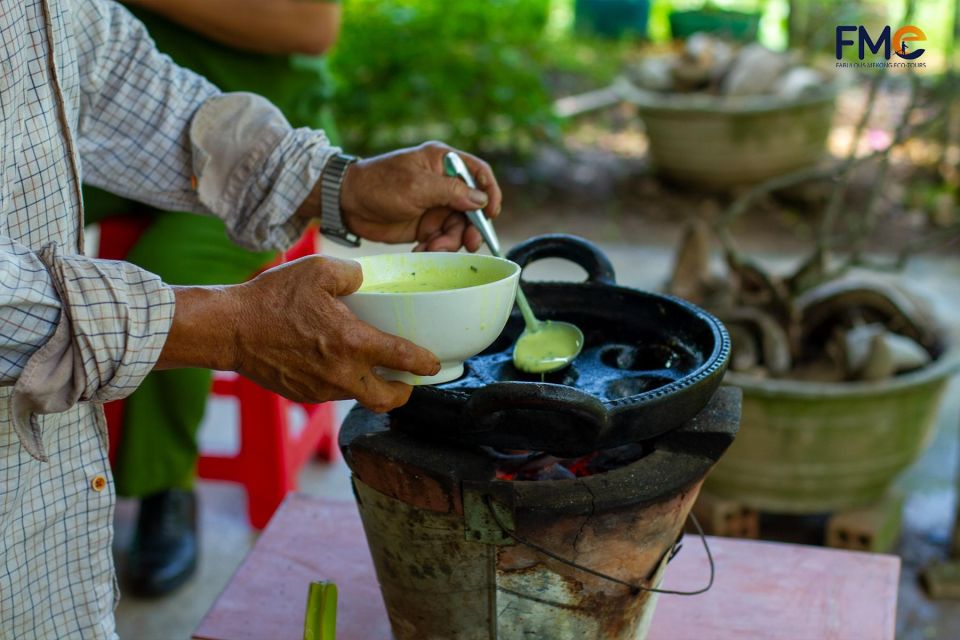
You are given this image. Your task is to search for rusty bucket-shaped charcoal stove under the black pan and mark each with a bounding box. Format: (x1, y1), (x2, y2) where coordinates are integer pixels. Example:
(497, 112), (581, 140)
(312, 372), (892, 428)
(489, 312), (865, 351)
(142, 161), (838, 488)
(340, 388), (740, 640)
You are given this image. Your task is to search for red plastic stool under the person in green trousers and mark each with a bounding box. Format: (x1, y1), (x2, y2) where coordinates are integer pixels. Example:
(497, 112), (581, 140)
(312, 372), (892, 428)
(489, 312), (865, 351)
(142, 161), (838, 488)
(98, 216), (337, 529)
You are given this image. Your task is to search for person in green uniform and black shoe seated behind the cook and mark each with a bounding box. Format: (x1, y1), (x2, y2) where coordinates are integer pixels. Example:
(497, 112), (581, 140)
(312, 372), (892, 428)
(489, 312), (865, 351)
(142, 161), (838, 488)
(84, 0), (340, 596)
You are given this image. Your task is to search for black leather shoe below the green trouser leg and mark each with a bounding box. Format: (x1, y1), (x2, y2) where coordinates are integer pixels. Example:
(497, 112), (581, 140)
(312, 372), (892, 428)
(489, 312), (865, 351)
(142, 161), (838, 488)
(127, 489), (197, 596)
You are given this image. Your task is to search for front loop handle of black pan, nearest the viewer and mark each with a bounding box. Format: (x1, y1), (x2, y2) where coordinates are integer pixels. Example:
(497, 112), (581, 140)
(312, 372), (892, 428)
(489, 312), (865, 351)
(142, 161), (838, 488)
(465, 382), (610, 439)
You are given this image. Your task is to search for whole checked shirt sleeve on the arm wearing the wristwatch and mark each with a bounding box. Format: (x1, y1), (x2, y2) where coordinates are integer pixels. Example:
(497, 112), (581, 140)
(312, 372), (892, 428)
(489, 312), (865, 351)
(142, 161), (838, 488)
(74, 0), (338, 249)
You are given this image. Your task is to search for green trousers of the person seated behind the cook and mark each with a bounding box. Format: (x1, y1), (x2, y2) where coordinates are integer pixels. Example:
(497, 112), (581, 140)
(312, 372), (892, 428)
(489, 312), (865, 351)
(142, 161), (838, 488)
(86, 198), (276, 497)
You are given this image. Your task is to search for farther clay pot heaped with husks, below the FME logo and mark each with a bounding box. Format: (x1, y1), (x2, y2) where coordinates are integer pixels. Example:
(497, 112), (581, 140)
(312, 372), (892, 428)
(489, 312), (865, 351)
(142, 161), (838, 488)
(620, 34), (836, 190)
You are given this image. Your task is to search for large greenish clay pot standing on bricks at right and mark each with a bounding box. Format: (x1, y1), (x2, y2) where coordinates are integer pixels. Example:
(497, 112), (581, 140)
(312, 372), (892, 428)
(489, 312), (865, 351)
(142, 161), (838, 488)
(704, 349), (960, 514)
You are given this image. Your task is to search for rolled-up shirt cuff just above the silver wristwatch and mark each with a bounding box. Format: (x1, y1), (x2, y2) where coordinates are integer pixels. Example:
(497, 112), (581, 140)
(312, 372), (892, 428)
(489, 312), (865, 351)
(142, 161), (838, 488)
(190, 93), (340, 250)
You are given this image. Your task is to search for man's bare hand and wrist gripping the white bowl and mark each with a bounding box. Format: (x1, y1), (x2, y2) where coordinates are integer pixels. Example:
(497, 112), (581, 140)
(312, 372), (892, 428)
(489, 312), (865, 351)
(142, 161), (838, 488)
(157, 256), (440, 412)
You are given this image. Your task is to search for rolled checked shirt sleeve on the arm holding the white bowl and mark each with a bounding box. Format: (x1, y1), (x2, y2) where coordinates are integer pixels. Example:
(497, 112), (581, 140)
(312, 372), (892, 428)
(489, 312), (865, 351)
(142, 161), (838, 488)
(0, 236), (174, 460)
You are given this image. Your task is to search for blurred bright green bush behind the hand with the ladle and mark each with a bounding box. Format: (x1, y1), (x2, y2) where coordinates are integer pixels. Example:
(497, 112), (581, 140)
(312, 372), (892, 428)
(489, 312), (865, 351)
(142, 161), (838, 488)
(331, 0), (557, 153)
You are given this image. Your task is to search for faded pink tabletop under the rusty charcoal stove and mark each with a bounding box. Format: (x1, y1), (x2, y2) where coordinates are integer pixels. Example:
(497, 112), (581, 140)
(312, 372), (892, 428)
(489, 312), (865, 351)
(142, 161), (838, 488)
(193, 494), (900, 640)
